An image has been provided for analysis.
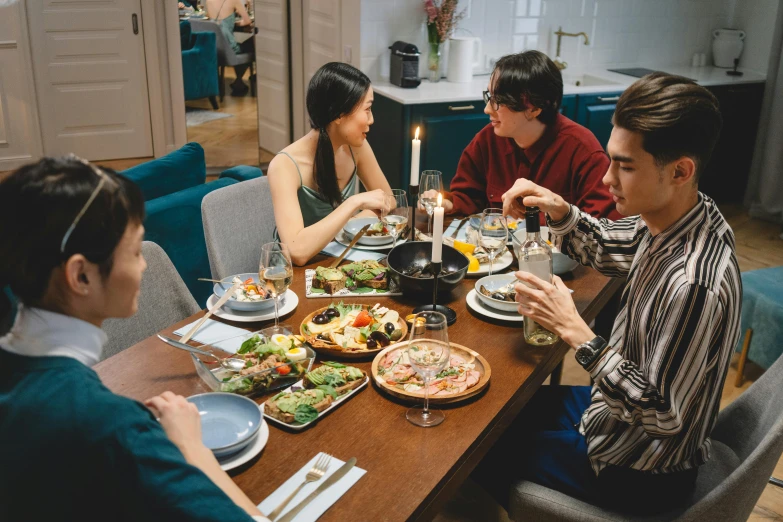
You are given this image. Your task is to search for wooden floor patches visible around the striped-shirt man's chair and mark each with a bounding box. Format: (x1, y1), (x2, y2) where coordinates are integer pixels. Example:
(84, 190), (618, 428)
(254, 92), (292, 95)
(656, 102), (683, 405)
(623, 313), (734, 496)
(435, 205), (783, 522)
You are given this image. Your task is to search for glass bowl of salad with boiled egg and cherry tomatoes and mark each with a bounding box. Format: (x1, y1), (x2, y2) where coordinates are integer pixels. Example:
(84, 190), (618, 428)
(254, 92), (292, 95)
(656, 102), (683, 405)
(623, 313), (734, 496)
(191, 332), (315, 395)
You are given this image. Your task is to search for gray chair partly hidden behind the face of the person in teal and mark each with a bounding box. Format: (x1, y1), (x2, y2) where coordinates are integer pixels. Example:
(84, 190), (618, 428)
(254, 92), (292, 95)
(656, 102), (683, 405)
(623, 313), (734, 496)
(103, 241), (201, 359)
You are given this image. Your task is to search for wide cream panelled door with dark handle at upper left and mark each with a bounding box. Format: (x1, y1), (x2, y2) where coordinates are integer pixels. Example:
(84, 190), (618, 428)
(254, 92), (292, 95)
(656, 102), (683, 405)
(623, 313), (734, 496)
(27, 0), (152, 160)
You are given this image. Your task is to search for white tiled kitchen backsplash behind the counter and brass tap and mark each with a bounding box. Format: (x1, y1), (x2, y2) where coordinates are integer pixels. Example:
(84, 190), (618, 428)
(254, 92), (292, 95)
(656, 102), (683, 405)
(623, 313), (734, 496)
(361, 0), (766, 79)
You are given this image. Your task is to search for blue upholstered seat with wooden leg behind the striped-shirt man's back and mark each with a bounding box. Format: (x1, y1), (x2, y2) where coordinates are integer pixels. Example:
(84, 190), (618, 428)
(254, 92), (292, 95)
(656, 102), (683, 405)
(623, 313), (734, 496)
(735, 266), (783, 386)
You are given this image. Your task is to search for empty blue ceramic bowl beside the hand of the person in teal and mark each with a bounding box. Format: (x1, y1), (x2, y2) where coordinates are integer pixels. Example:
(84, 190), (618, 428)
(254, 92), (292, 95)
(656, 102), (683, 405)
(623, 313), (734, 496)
(188, 392), (261, 458)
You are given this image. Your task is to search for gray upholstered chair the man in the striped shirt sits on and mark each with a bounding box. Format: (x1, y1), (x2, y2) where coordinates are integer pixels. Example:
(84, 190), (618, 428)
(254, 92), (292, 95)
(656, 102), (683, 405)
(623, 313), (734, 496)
(509, 350), (783, 522)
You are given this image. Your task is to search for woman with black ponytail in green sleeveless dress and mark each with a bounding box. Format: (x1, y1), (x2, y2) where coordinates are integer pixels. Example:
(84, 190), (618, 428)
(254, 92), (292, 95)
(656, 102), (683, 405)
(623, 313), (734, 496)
(268, 62), (391, 266)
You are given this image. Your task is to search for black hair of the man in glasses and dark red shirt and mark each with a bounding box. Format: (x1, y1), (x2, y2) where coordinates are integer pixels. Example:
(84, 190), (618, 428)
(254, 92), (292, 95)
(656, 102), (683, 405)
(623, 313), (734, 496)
(491, 51), (563, 125)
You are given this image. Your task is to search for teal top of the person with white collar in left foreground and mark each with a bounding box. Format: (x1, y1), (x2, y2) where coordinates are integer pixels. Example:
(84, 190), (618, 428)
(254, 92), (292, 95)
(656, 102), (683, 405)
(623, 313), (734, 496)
(0, 349), (253, 522)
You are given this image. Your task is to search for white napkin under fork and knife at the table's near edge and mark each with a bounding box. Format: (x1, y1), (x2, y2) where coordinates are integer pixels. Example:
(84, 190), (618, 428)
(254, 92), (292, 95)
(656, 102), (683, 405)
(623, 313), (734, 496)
(258, 453), (367, 522)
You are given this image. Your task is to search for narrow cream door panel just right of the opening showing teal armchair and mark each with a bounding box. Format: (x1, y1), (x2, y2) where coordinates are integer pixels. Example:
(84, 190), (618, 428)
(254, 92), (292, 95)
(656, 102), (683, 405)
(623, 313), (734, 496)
(254, 0), (291, 152)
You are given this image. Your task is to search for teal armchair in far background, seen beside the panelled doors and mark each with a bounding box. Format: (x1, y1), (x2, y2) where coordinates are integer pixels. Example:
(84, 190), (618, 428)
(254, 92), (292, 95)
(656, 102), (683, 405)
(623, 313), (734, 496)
(179, 20), (220, 109)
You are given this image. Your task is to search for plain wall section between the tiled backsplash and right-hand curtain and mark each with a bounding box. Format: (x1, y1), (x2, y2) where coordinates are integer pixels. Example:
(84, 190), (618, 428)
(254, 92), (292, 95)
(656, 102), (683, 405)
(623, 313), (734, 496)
(734, 0), (783, 73)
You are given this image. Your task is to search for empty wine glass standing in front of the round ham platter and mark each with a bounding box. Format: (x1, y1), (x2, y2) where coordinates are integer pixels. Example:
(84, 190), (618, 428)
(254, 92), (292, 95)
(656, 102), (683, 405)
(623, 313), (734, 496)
(405, 311), (449, 428)
